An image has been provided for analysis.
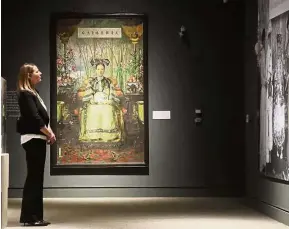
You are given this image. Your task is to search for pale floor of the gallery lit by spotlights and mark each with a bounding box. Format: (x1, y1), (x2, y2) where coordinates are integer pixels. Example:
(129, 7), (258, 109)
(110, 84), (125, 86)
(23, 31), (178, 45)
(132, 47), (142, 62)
(8, 198), (289, 229)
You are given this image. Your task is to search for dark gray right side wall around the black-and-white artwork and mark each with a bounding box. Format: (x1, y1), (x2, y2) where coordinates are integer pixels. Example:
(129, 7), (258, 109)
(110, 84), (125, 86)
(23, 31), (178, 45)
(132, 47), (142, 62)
(244, 0), (289, 224)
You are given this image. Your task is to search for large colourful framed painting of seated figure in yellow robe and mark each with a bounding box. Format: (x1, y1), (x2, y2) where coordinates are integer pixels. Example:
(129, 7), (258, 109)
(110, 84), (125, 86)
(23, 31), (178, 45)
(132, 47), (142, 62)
(50, 13), (149, 175)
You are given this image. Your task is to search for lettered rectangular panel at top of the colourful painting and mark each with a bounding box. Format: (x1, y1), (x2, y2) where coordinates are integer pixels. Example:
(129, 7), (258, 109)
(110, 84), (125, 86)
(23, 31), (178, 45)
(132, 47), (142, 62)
(77, 28), (122, 38)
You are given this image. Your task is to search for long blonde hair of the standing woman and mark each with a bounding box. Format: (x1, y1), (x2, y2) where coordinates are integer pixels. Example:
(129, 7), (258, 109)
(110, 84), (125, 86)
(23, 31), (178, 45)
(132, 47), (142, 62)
(17, 63), (36, 94)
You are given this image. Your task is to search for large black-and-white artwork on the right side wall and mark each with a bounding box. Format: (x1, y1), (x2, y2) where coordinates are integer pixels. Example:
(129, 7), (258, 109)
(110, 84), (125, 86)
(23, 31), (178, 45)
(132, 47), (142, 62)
(255, 0), (289, 182)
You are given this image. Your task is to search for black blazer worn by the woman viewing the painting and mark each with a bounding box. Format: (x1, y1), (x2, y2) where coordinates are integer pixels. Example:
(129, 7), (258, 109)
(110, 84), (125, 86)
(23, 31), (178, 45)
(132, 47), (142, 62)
(17, 90), (50, 135)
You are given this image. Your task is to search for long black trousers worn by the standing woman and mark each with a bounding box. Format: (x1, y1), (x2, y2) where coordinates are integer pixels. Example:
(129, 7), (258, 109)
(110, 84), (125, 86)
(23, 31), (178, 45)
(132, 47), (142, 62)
(20, 138), (46, 223)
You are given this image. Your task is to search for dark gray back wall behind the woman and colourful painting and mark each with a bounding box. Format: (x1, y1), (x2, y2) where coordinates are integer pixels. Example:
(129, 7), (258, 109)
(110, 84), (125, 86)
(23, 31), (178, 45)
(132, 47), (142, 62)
(2, 0), (245, 196)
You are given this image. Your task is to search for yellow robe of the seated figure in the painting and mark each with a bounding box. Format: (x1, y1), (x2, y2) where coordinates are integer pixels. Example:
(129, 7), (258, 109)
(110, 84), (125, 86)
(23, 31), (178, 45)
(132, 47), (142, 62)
(79, 77), (124, 143)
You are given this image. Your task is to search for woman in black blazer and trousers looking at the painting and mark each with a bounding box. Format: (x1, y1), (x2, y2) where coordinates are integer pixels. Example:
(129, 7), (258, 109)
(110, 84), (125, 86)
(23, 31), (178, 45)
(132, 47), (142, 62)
(17, 64), (56, 226)
